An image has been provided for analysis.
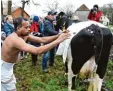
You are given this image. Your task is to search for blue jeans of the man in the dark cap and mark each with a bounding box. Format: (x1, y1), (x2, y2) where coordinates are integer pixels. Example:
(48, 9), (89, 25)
(42, 48), (55, 70)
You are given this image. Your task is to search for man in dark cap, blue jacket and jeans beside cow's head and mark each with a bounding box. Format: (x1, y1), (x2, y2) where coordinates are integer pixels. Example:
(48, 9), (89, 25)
(42, 11), (58, 72)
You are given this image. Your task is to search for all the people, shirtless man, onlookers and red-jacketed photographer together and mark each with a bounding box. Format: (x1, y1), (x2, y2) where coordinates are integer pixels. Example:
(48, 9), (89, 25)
(1, 5), (102, 91)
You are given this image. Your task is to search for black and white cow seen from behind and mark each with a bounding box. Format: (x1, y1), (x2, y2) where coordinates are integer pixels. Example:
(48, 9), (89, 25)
(56, 13), (112, 91)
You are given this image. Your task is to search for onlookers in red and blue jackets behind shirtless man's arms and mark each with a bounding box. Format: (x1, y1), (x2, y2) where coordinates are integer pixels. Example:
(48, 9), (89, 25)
(30, 11), (59, 72)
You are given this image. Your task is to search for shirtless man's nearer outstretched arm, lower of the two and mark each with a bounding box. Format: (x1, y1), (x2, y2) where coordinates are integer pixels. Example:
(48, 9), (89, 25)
(14, 33), (70, 54)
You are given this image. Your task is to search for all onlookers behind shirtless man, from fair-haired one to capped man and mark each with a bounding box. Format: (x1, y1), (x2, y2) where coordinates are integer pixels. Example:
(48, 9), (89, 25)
(1, 11), (59, 72)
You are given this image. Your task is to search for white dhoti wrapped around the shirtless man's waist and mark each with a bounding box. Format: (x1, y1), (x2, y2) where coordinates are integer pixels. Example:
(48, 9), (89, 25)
(1, 60), (16, 91)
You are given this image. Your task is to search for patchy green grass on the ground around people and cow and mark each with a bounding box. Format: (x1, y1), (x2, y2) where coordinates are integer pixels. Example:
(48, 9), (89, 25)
(14, 56), (113, 91)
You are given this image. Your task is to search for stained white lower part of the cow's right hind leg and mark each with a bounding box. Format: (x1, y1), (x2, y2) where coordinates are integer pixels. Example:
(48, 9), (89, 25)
(88, 74), (103, 91)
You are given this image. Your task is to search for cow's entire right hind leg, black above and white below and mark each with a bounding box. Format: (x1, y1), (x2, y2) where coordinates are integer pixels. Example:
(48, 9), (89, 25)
(88, 35), (112, 91)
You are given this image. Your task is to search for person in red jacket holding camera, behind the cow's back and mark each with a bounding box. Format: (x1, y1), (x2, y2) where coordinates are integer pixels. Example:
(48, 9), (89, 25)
(88, 5), (103, 22)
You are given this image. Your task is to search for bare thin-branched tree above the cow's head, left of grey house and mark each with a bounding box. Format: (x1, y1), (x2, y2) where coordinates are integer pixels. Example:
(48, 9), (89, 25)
(60, 4), (75, 18)
